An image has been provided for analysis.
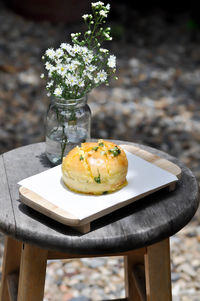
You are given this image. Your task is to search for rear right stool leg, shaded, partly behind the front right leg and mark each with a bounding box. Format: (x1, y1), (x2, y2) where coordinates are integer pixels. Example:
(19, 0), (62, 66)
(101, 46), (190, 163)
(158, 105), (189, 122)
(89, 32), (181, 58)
(124, 251), (144, 301)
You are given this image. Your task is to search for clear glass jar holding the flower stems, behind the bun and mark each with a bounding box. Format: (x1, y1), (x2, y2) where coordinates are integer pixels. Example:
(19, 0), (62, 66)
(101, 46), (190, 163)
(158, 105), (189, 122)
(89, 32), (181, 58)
(46, 96), (91, 165)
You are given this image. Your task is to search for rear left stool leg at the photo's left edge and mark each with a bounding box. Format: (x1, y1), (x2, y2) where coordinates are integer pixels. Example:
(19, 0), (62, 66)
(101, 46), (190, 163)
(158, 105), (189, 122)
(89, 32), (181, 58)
(0, 236), (21, 301)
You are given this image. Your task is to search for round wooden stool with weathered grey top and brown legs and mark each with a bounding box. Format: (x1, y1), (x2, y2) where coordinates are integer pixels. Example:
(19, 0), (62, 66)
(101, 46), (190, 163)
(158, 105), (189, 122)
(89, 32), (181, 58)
(0, 141), (198, 301)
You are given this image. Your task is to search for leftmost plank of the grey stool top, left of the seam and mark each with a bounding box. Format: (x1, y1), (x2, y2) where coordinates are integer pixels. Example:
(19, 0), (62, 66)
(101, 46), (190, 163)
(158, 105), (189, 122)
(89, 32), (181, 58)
(0, 156), (15, 235)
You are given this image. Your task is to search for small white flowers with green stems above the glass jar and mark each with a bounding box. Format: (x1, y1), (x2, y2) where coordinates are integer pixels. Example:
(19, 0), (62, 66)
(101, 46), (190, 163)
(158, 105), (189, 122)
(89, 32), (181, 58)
(41, 1), (116, 99)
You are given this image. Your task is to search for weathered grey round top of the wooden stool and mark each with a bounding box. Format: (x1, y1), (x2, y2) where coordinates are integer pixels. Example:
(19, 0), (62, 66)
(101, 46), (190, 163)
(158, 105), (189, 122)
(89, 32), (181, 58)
(0, 141), (199, 255)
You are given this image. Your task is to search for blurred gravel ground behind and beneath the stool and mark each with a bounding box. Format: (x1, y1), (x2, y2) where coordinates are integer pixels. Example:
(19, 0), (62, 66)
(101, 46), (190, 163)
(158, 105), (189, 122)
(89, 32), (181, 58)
(0, 2), (200, 301)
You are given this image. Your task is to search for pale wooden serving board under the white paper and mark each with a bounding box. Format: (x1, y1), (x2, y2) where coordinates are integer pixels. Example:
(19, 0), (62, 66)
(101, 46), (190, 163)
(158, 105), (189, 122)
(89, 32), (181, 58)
(19, 144), (181, 233)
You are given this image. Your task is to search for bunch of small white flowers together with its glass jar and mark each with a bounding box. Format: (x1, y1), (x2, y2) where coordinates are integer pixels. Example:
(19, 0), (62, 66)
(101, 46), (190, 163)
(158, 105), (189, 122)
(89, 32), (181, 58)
(41, 1), (116, 164)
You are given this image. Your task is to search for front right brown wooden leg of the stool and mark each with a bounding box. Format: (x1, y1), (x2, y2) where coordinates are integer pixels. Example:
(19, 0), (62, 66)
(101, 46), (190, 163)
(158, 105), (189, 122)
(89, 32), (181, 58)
(145, 239), (172, 301)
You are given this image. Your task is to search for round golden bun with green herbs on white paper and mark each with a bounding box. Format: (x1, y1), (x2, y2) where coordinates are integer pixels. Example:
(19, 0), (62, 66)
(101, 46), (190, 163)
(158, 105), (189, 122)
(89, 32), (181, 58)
(62, 140), (128, 194)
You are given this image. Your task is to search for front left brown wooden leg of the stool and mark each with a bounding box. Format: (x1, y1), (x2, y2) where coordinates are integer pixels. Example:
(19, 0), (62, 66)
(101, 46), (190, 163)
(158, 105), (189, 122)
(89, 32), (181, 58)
(17, 244), (48, 301)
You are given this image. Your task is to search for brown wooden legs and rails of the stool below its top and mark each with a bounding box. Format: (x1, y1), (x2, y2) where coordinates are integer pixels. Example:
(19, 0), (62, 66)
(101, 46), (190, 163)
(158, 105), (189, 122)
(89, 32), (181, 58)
(0, 237), (172, 301)
